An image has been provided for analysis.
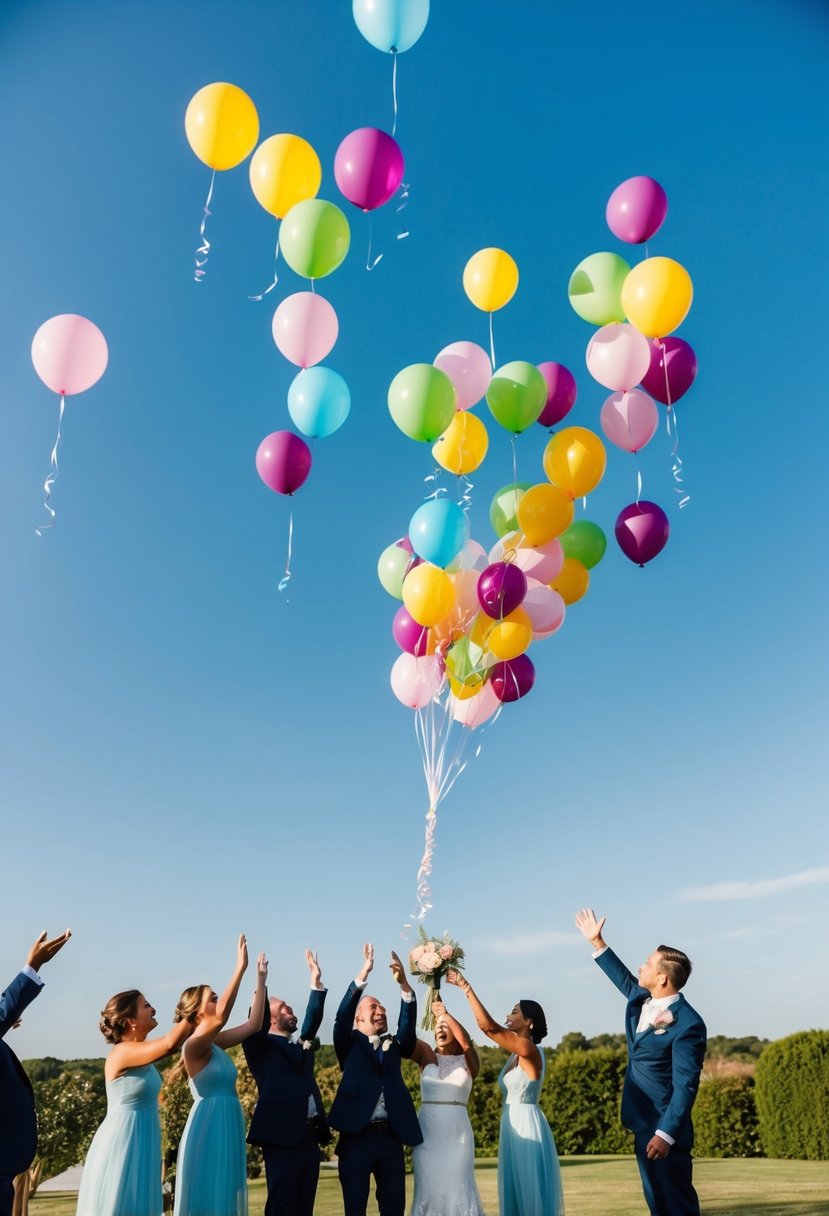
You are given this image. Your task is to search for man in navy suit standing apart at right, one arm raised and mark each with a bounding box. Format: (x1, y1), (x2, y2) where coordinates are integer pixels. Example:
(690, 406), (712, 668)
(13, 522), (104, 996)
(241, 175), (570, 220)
(576, 908), (706, 1216)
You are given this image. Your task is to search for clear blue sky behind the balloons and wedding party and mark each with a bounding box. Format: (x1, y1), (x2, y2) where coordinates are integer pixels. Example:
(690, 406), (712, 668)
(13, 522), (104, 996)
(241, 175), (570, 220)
(0, 0), (829, 1055)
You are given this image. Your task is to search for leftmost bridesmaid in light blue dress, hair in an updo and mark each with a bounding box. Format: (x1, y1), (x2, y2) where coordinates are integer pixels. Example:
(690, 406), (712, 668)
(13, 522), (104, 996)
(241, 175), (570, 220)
(78, 989), (192, 1216)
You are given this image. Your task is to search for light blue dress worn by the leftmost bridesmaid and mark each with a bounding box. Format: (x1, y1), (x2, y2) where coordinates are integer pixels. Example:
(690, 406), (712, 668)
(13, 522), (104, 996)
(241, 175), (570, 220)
(78, 1064), (162, 1216)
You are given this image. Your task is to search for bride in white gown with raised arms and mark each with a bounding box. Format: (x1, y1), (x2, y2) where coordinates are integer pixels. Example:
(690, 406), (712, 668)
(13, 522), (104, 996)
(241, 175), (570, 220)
(411, 1000), (484, 1216)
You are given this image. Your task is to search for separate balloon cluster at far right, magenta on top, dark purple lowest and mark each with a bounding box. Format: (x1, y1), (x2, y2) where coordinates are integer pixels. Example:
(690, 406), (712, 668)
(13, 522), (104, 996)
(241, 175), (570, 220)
(568, 176), (697, 565)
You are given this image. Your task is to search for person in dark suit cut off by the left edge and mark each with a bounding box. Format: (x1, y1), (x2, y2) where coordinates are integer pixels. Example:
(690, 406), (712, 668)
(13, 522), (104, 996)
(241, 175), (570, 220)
(0, 929), (72, 1216)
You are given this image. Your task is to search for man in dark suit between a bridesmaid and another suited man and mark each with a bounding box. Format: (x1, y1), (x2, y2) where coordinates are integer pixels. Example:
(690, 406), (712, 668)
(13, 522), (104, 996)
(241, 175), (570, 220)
(242, 950), (331, 1216)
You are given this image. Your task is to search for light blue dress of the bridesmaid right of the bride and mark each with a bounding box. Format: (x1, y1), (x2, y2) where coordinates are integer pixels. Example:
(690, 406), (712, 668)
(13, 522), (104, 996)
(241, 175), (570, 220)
(498, 1048), (564, 1216)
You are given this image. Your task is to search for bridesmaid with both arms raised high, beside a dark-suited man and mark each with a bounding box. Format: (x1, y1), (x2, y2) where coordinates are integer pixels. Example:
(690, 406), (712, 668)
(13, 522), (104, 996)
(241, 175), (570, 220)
(175, 935), (267, 1216)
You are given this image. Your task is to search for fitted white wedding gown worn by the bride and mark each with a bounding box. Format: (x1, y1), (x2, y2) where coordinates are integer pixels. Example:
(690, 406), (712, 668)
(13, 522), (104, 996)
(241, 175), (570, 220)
(411, 1055), (484, 1216)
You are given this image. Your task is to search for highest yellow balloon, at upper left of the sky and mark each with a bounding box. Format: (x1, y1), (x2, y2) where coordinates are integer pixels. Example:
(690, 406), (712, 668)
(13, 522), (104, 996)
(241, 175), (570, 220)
(185, 81), (259, 169)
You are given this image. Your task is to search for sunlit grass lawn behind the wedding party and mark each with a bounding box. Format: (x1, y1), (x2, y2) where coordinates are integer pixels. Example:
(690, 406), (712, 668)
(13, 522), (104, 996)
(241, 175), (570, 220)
(29, 1156), (829, 1216)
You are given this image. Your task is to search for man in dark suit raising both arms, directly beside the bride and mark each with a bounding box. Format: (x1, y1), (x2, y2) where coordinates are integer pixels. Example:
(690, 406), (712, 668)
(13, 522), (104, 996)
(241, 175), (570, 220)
(328, 945), (423, 1216)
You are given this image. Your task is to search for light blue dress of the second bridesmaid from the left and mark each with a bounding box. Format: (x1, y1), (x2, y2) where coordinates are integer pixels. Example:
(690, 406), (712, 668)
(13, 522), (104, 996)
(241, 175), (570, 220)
(168, 1043), (248, 1216)
